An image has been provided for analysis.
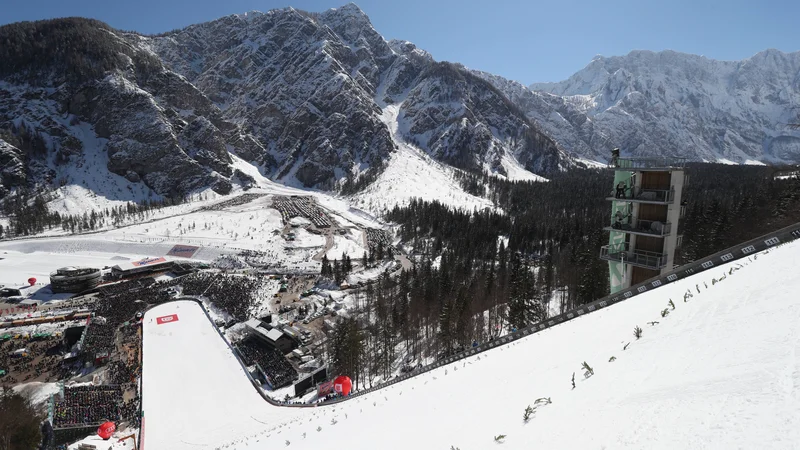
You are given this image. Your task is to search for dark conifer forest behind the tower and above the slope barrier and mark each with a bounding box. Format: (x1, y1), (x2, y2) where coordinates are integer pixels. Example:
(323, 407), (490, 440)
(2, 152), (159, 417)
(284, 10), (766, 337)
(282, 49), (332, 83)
(329, 164), (800, 386)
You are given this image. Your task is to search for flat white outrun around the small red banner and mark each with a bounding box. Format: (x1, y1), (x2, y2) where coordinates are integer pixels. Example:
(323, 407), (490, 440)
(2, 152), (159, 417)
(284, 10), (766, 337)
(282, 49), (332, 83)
(140, 300), (300, 450)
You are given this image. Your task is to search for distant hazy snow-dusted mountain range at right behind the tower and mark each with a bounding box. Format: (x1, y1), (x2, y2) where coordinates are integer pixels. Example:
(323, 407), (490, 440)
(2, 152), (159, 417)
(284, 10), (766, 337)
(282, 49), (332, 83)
(520, 50), (800, 163)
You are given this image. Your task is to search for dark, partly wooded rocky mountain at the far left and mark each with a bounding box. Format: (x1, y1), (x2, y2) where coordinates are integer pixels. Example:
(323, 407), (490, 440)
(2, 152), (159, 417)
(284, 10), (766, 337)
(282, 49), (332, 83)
(0, 19), (250, 196)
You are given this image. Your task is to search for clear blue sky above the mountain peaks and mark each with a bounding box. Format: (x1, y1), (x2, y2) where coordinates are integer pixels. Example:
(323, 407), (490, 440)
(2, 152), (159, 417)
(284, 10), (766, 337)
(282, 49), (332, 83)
(0, 0), (800, 84)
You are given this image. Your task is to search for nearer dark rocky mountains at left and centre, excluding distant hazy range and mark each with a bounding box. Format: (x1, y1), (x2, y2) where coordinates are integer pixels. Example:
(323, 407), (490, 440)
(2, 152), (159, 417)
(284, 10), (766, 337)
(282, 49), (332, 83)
(0, 4), (574, 202)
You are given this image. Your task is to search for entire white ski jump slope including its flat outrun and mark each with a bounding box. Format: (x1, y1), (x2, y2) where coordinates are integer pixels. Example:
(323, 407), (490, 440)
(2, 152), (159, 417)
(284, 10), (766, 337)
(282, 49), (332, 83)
(140, 224), (800, 450)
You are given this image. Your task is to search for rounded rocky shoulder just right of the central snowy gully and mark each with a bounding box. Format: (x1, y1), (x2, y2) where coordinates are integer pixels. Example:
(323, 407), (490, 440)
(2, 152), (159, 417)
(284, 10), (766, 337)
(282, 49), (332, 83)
(400, 63), (563, 173)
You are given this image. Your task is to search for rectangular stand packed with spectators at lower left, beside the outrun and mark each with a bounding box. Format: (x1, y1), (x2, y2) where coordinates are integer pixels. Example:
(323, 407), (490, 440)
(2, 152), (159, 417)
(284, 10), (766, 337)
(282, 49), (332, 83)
(53, 386), (122, 428)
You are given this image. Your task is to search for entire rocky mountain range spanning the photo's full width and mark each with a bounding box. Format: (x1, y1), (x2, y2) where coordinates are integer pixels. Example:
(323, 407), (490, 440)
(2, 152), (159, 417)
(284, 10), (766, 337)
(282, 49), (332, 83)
(0, 4), (800, 202)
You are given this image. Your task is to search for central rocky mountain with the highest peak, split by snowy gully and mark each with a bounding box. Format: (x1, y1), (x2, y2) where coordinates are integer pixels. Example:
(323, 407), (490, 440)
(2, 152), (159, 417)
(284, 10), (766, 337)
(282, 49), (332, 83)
(150, 4), (568, 188)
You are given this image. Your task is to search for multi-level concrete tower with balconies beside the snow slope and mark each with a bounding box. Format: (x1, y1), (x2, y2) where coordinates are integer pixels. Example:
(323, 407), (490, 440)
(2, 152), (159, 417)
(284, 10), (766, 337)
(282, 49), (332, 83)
(600, 149), (686, 294)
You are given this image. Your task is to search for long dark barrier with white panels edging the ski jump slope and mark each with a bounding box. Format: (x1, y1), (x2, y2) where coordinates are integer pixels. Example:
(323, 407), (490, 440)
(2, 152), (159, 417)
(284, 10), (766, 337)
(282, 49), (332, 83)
(142, 223), (800, 418)
